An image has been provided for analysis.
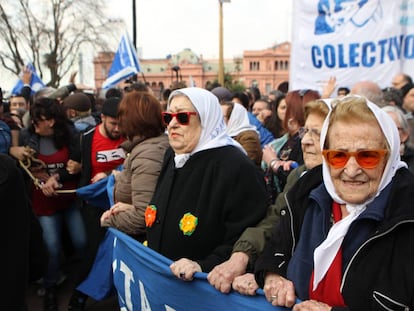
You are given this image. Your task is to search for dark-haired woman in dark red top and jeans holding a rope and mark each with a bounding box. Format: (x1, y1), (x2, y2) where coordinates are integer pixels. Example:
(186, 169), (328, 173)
(20, 98), (86, 310)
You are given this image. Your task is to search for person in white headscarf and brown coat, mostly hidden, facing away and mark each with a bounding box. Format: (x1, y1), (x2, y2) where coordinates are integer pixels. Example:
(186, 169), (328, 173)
(221, 102), (263, 167)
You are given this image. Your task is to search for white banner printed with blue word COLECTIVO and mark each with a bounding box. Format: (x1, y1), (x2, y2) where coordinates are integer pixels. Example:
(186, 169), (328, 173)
(290, 0), (414, 91)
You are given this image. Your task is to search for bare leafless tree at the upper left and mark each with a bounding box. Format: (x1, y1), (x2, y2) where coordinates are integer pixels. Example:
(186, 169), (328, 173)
(0, 0), (121, 87)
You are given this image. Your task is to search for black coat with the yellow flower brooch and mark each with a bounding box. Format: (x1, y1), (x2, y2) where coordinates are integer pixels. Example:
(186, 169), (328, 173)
(147, 146), (267, 272)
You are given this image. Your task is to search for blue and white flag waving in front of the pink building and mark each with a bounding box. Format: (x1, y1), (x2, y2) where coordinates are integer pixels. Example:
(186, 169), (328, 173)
(102, 34), (141, 89)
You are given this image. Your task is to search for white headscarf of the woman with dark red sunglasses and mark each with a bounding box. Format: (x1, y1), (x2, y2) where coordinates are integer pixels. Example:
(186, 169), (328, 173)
(168, 87), (246, 168)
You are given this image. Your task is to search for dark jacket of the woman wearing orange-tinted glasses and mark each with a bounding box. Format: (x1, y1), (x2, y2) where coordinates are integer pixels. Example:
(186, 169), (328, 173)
(255, 168), (414, 310)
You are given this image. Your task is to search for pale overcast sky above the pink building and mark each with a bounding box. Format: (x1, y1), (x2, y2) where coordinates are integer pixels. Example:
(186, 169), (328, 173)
(108, 0), (293, 59)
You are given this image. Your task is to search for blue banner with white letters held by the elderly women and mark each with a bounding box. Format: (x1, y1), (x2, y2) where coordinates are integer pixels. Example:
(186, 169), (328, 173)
(109, 228), (290, 311)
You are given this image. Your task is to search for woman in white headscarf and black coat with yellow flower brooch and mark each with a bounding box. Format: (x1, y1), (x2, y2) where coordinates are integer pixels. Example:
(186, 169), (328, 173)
(145, 88), (267, 280)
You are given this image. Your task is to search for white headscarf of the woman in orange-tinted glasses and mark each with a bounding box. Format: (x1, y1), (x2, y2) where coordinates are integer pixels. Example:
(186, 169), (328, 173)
(313, 95), (407, 290)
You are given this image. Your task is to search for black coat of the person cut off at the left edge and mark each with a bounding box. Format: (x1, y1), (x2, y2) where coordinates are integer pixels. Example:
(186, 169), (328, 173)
(0, 154), (47, 311)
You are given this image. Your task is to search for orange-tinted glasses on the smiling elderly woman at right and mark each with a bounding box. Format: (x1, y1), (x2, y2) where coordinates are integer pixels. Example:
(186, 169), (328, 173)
(322, 149), (388, 168)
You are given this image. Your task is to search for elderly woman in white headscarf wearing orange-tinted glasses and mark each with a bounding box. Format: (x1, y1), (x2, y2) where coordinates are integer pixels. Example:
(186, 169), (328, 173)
(255, 96), (414, 310)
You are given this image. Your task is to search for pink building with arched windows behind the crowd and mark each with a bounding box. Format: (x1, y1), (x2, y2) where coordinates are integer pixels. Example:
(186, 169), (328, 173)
(94, 42), (291, 95)
